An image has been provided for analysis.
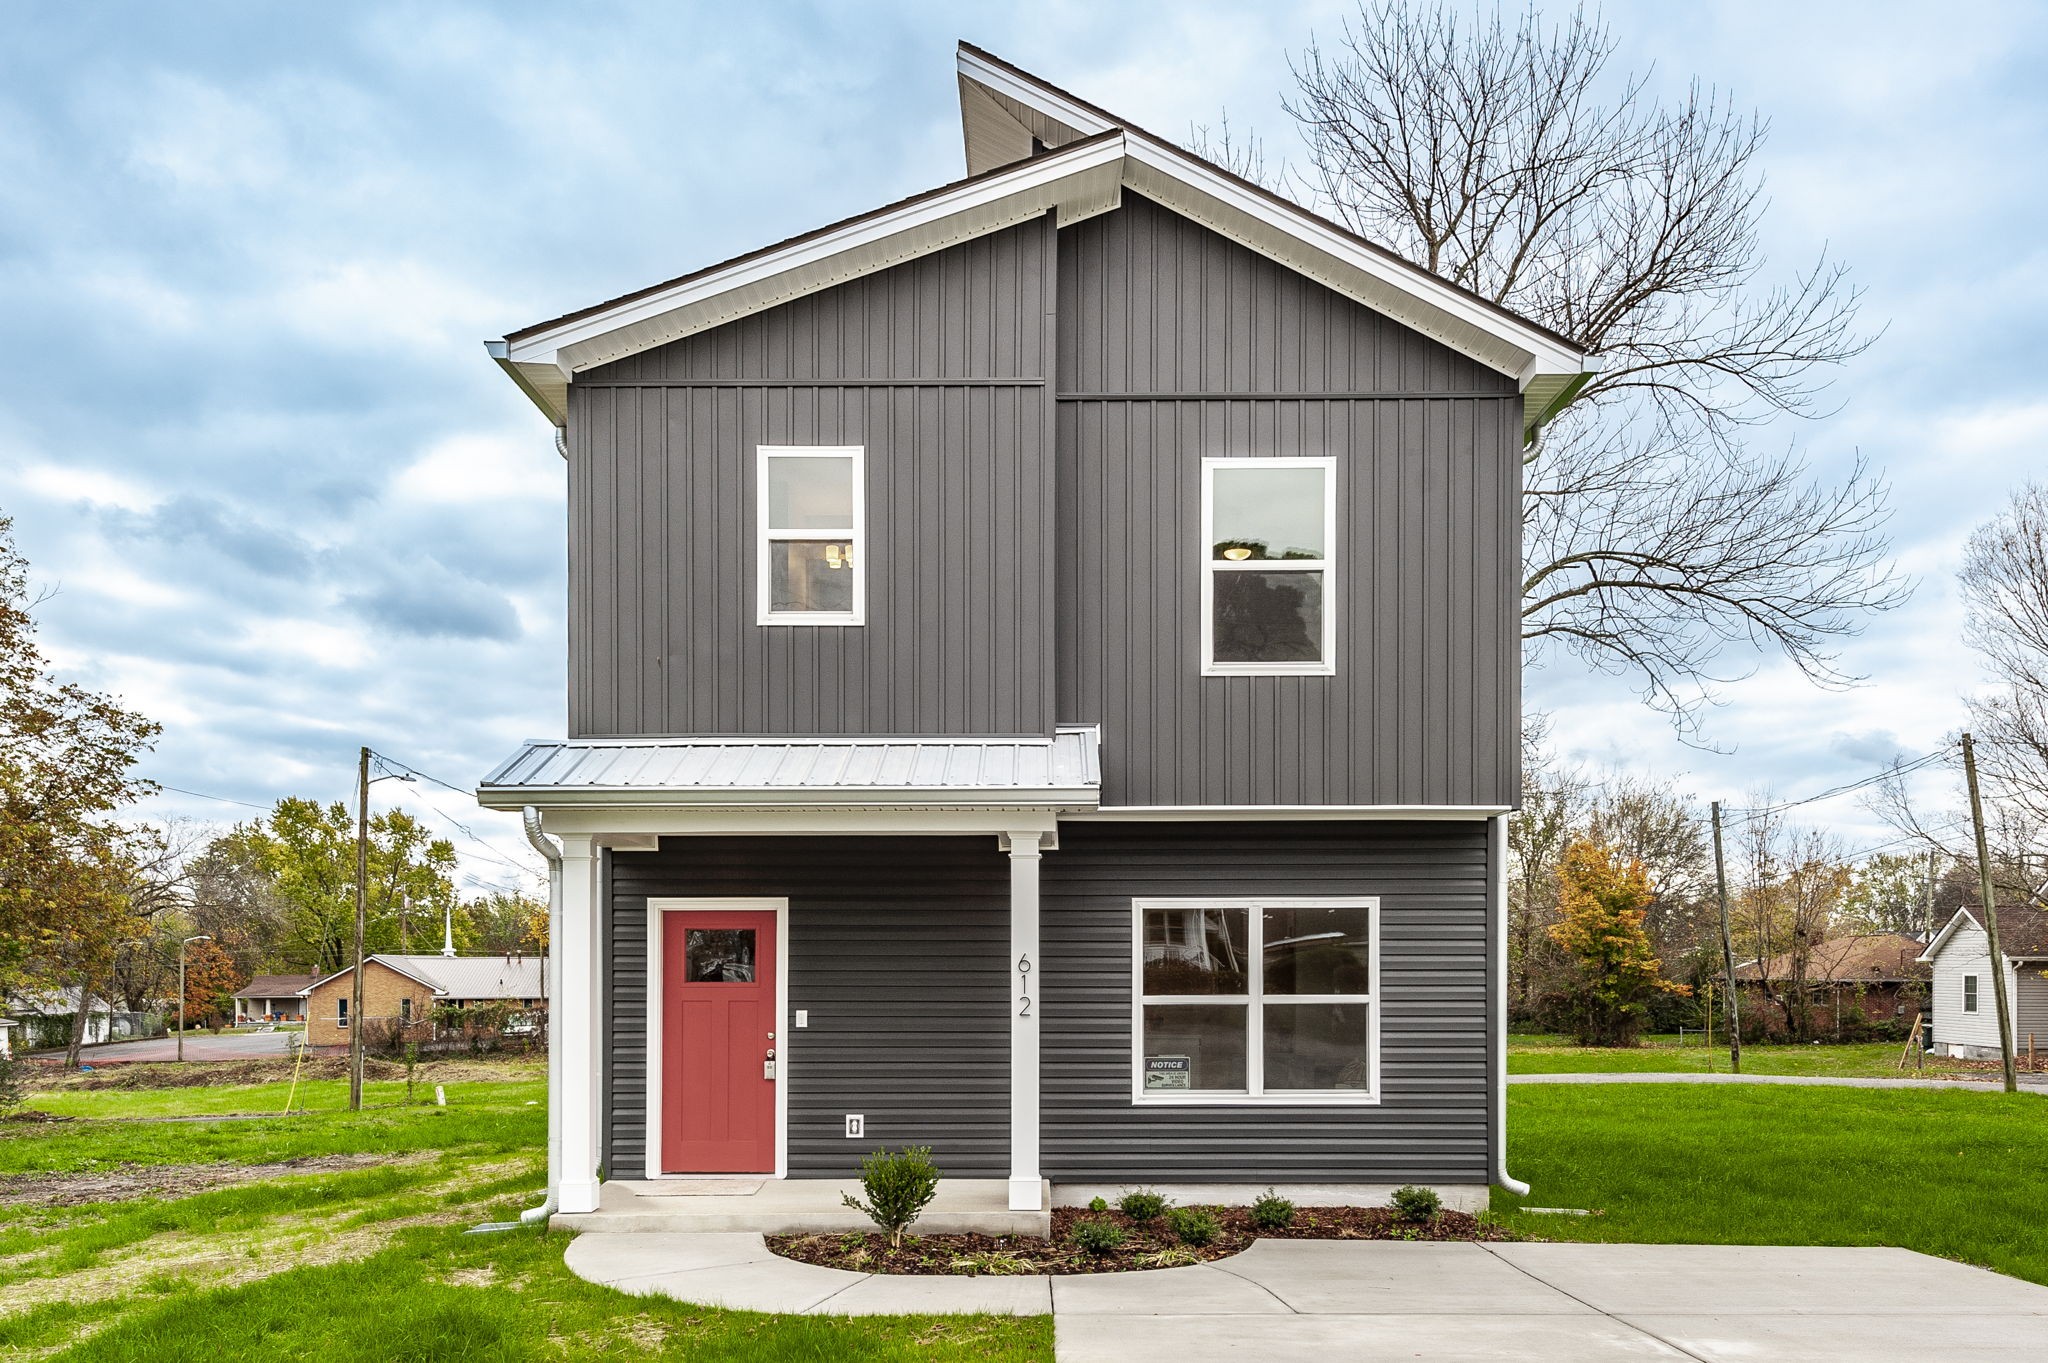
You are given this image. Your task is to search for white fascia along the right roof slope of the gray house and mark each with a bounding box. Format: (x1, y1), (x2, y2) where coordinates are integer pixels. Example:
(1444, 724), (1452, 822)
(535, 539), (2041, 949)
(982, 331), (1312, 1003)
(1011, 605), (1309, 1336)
(1124, 133), (1597, 387)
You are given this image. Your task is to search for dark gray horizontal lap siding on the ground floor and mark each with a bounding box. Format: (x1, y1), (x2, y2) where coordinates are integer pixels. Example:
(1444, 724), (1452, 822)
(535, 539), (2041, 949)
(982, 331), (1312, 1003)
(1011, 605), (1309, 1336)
(604, 821), (1499, 1183)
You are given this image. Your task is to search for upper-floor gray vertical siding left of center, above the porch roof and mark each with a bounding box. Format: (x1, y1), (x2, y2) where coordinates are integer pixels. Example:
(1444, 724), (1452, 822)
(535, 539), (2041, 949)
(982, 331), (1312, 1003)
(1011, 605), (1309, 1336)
(569, 217), (1055, 737)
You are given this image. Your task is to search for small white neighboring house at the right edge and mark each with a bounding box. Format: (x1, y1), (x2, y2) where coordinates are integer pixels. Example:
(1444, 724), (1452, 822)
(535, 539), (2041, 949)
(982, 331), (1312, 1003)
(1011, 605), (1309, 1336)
(1921, 905), (2048, 1060)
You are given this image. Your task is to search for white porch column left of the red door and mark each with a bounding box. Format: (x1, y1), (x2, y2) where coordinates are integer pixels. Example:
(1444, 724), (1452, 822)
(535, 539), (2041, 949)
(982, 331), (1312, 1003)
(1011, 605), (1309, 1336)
(549, 835), (600, 1212)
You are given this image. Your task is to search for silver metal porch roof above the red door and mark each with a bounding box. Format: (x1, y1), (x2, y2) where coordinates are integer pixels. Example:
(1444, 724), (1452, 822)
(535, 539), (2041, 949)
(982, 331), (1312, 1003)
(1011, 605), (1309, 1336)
(477, 724), (1102, 808)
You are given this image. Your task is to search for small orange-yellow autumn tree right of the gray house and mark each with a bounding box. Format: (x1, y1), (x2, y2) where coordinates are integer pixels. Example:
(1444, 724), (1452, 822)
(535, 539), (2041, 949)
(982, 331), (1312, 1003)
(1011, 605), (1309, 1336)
(1550, 839), (1692, 1046)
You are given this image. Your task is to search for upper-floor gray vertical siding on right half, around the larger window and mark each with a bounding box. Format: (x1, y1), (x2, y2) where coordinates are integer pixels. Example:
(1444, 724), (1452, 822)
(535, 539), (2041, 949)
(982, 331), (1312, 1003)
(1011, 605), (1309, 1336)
(1055, 192), (1522, 806)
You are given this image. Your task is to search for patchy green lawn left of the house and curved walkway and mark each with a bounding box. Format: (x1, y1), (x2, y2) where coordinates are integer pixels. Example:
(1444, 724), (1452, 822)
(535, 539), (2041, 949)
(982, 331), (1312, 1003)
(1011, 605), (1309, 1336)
(0, 1079), (1053, 1363)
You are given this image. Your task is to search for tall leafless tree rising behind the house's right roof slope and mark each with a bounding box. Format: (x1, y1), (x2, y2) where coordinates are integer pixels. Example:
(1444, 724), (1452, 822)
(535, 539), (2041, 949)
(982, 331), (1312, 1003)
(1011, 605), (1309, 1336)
(1198, 0), (1907, 731)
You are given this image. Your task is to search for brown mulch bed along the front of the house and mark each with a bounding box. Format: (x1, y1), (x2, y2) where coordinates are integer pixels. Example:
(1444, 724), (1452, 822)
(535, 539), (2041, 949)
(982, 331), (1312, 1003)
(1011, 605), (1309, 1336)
(768, 1207), (1520, 1277)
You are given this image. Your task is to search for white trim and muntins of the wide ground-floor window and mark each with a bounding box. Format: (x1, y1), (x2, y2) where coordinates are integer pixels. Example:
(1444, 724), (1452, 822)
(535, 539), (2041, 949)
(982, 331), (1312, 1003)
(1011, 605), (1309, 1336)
(1130, 894), (1380, 1107)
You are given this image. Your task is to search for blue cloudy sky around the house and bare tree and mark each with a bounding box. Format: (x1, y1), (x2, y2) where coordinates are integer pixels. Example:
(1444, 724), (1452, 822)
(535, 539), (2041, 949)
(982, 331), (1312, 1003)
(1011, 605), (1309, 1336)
(0, 0), (2048, 884)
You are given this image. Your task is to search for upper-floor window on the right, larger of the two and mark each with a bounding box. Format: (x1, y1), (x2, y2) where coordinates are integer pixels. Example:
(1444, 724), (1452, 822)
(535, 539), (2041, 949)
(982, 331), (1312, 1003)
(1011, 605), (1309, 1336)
(1202, 458), (1337, 677)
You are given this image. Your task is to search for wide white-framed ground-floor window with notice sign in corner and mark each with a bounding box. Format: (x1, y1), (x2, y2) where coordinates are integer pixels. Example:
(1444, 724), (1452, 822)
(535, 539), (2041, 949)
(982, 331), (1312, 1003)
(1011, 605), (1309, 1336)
(1130, 896), (1380, 1105)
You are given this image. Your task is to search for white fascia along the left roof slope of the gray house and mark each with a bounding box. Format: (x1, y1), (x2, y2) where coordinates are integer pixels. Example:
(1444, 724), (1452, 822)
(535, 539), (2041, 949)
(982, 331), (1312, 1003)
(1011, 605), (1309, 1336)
(494, 137), (1124, 375)
